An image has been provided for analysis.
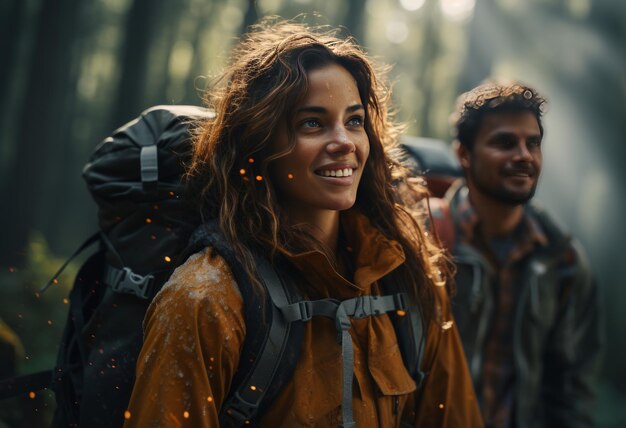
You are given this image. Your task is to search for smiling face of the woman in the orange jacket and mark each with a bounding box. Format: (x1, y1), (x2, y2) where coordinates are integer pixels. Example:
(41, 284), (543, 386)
(271, 64), (369, 221)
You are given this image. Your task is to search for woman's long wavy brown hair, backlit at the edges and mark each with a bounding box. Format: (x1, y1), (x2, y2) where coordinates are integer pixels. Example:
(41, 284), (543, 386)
(188, 20), (447, 324)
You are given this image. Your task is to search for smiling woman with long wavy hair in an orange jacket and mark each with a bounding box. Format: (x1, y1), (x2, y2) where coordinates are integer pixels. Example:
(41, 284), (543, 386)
(125, 19), (481, 427)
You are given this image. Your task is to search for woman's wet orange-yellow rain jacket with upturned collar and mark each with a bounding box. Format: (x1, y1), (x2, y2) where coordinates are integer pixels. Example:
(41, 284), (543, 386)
(124, 211), (482, 428)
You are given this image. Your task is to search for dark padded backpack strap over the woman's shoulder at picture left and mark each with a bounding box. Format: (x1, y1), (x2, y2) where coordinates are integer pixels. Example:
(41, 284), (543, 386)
(186, 221), (304, 427)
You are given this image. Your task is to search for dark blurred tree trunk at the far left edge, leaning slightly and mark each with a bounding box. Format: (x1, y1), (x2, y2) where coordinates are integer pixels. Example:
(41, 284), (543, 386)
(0, 0), (81, 266)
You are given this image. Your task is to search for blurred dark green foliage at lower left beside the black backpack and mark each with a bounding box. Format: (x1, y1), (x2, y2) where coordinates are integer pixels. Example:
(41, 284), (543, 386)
(0, 233), (78, 427)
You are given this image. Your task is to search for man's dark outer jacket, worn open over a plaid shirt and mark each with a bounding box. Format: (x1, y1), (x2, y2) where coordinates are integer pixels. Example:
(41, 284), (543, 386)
(434, 183), (601, 428)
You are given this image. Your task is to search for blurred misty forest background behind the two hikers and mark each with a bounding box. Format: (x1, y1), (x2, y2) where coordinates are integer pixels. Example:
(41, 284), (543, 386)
(0, 0), (626, 428)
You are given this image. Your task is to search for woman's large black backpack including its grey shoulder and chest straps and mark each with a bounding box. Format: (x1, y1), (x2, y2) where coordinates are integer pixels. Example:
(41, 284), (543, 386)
(0, 106), (425, 428)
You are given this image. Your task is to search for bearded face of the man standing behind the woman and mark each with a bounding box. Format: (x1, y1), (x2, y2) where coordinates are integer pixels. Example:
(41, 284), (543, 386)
(459, 111), (542, 205)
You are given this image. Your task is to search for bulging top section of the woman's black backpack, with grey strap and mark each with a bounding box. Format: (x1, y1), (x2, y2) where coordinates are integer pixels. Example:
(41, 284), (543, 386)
(83, 106), (214, 299)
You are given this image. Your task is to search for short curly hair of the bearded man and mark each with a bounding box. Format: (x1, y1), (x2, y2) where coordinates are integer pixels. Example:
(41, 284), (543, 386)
(451, 80), (546, 150)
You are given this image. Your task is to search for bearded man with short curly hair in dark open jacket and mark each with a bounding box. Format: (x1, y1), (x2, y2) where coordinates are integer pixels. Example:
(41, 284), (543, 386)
(433, 82), (600, 428)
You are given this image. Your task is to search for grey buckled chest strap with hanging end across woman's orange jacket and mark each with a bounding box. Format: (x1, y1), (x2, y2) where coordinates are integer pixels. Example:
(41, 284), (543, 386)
(279, 293), (408, 428)
